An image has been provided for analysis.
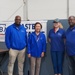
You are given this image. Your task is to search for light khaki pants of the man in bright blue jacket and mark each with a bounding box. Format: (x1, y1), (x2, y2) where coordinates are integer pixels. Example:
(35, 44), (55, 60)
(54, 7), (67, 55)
(8, 48), (26, 75)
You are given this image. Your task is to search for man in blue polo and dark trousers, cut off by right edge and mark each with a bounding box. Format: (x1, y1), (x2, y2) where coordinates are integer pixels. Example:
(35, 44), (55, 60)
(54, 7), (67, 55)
(66, 16), (75, 75)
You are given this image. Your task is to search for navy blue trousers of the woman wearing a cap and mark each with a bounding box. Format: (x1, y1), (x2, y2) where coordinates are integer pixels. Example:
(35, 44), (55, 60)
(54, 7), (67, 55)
(51, 51), (64, 74)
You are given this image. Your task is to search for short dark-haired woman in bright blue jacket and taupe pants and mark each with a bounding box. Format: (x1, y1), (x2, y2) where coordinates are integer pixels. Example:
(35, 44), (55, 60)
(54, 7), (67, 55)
(28, 22), (46, 75)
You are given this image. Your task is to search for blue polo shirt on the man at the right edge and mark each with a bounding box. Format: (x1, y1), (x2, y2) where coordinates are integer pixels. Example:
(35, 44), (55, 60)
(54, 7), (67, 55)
(66, 26), (75, 56)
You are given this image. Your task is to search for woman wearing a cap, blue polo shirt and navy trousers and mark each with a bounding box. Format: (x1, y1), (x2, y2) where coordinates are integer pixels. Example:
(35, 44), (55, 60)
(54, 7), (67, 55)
(48, 19), (65, 75)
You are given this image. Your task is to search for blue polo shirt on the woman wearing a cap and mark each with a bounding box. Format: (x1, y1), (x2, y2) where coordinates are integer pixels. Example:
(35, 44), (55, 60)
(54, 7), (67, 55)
(48, 29), (65, 51)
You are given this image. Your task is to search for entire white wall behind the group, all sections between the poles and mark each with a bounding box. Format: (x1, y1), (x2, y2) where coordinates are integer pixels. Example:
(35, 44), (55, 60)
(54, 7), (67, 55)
(0, 0), (75, 21)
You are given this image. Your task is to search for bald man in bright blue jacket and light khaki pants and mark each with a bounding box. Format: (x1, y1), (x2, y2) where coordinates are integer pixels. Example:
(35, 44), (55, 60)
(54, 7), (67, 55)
(5, 16), (27, 75)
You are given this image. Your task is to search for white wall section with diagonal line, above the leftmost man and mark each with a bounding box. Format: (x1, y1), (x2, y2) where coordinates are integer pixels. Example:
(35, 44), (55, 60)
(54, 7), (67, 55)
(0, 0), (23, 21)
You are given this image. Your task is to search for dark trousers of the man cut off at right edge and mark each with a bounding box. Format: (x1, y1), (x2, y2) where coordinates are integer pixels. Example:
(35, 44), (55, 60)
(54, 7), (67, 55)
(68, 56), (75, 75)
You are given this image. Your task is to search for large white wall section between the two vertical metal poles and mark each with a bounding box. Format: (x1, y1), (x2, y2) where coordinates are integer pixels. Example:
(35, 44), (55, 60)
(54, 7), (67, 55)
(28, 0), (67, 20)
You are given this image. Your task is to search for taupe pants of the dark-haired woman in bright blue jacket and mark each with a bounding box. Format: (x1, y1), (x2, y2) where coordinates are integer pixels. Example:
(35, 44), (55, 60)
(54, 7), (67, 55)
(30, 57), (41, 75)
